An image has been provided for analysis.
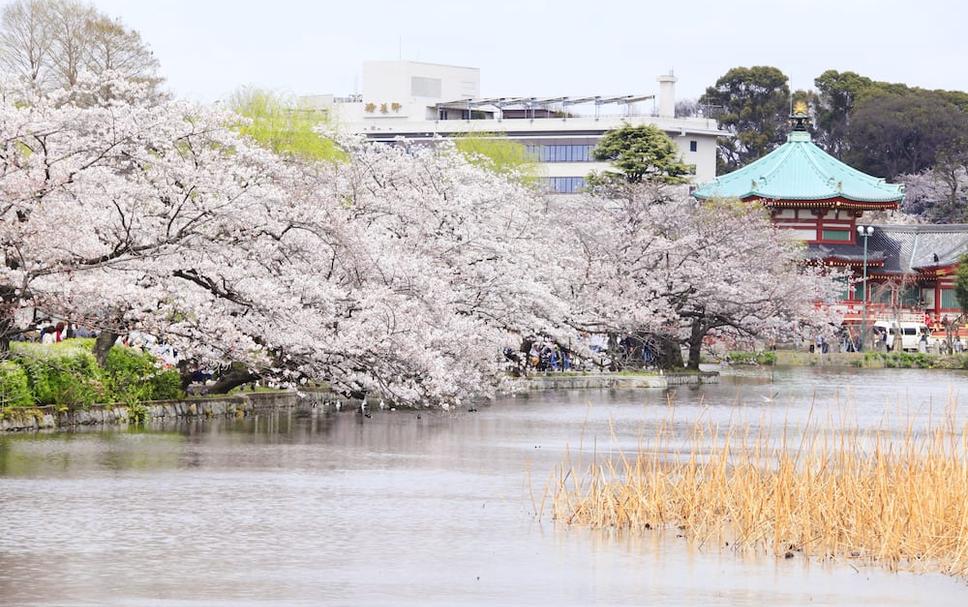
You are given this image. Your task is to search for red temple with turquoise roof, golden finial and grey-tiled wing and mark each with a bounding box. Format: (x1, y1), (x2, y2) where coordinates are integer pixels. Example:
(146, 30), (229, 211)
(693, 107), (968, 335)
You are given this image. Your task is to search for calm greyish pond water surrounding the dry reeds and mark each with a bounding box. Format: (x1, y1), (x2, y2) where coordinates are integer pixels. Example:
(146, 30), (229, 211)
(0, 369), (968, 606)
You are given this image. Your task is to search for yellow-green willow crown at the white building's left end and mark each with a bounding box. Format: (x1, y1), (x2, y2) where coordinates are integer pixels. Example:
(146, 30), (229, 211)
(230, 88), (346, 161)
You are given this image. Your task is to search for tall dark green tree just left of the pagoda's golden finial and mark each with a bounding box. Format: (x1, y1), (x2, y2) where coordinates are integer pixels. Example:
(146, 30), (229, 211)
(699, 66), (790, 172)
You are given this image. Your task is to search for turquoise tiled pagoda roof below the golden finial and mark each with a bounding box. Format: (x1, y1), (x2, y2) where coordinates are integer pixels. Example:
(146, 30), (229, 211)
(693, 130), (904, 208)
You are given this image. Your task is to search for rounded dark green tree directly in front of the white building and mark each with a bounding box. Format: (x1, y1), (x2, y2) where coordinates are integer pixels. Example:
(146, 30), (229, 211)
(589, 124), (694, 185)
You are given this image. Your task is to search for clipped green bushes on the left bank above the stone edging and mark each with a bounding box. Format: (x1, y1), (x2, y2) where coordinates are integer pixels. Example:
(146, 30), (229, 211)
(0, 339), (184, 408)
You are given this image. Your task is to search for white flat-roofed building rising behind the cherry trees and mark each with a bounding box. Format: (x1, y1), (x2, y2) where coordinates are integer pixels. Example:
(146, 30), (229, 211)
(302, 61), (725, 193)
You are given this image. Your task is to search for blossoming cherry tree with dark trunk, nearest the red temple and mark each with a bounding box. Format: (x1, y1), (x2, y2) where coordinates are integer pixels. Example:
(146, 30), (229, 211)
(562, 185), (839, 369)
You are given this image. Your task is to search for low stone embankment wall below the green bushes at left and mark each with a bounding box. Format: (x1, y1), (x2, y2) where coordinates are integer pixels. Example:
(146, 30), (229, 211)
(0, 391), (348, 432)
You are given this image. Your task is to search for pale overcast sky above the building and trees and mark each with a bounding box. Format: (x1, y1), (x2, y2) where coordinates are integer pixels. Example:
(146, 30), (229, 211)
(85, 0), (968, 101)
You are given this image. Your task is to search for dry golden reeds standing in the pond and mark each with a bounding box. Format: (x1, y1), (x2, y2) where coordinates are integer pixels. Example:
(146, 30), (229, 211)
(539, 406), (968, 576)
